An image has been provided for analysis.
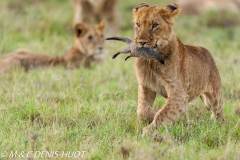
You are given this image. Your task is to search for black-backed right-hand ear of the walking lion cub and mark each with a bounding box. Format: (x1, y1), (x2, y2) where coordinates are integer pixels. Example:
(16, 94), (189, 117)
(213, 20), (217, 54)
(160, 3), (181, 25)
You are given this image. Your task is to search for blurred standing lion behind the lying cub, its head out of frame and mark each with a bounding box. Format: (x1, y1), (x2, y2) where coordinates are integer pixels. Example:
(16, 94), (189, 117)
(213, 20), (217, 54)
(71, 0), (120, 36)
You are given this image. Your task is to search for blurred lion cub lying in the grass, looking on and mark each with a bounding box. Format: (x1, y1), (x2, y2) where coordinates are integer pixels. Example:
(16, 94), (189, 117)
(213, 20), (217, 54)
(0, 22), (105, 71)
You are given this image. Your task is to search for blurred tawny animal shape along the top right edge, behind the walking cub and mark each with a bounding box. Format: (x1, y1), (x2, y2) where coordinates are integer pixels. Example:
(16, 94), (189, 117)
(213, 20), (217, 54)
(176, 0), (240, 14)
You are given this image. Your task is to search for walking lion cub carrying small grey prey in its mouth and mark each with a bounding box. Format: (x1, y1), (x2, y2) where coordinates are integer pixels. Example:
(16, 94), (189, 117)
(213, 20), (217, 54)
(133, 3), (223, 135)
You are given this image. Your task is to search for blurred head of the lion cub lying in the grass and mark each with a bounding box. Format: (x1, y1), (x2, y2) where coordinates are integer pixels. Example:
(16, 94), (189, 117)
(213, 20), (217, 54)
(74, 21), (105, 56)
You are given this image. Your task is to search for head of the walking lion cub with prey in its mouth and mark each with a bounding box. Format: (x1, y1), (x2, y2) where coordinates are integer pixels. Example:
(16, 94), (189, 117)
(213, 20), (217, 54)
(133, 3), (180, 47)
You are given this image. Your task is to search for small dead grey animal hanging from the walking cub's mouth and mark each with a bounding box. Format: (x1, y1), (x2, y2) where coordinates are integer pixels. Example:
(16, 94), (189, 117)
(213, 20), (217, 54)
(106, 37), (164, 64)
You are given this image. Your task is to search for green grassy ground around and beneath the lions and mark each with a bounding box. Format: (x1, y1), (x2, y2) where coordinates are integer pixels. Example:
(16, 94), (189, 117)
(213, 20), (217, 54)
(0, 0), (240, 160)
